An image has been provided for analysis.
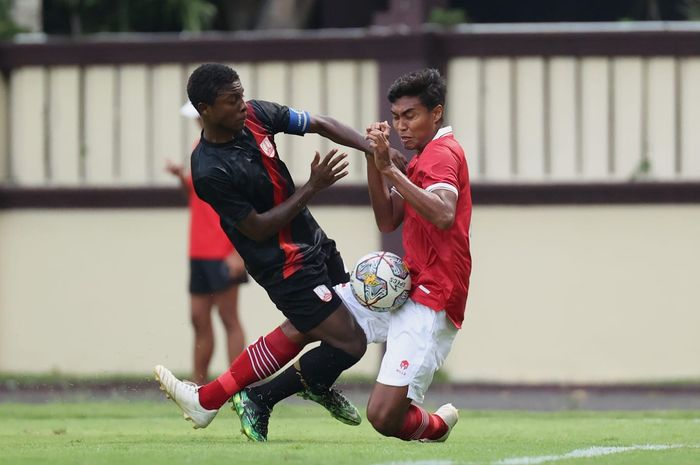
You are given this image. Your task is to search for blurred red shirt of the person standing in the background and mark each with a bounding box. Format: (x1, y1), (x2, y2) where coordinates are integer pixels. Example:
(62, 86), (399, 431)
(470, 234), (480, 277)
(186, 176), (233, 260)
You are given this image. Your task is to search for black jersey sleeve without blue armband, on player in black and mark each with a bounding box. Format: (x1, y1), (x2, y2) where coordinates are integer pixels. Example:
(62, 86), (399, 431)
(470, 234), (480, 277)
(194, 172), (253, 224)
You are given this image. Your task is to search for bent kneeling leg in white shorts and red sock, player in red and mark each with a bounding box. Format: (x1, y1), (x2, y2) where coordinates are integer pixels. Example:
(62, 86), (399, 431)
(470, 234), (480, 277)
(367, 300), (458, 441)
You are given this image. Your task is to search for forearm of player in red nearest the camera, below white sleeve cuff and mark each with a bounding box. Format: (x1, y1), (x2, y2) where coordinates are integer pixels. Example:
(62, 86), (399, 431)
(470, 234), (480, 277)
(382, 166), (454, 229)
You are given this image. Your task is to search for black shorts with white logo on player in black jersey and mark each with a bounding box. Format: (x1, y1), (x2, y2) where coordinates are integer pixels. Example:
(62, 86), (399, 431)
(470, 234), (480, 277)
(267, 249), (350, 333)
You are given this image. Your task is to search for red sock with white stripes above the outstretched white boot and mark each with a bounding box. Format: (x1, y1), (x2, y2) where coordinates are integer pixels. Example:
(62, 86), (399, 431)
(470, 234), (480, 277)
(199, 326), (302, 410)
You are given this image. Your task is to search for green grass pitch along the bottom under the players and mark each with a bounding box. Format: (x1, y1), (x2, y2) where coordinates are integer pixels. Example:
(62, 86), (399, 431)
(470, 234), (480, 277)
(0, 401), (700, 465)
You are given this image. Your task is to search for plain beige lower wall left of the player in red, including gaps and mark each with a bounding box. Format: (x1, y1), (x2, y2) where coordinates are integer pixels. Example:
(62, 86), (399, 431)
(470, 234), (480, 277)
(0, 208), (379, 373)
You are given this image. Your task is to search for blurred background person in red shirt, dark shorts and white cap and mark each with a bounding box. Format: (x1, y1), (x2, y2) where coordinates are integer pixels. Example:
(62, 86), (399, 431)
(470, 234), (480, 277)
(166, 102), (248, 384)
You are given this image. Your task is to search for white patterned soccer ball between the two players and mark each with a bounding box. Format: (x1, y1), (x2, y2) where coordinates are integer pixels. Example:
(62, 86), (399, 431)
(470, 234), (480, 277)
(350, 252), (411, 312)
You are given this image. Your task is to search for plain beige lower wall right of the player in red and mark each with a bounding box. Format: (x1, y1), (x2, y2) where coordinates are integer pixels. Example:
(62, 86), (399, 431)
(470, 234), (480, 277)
(447, 206), (700, 382)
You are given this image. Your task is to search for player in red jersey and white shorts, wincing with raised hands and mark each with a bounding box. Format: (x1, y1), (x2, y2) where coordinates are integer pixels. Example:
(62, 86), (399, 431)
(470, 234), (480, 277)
(336, 69), (472, 441)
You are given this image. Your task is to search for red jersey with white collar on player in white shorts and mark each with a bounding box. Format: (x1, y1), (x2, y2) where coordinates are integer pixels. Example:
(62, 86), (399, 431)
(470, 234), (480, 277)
(403, 126), (472, 328)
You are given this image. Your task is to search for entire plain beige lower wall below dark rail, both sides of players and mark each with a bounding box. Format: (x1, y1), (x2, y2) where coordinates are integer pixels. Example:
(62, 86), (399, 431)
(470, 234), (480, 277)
(0, 206), (700, 382)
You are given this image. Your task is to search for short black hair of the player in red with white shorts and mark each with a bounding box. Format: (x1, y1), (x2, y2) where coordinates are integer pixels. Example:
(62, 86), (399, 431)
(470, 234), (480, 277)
(387, 68), (447, 110)
